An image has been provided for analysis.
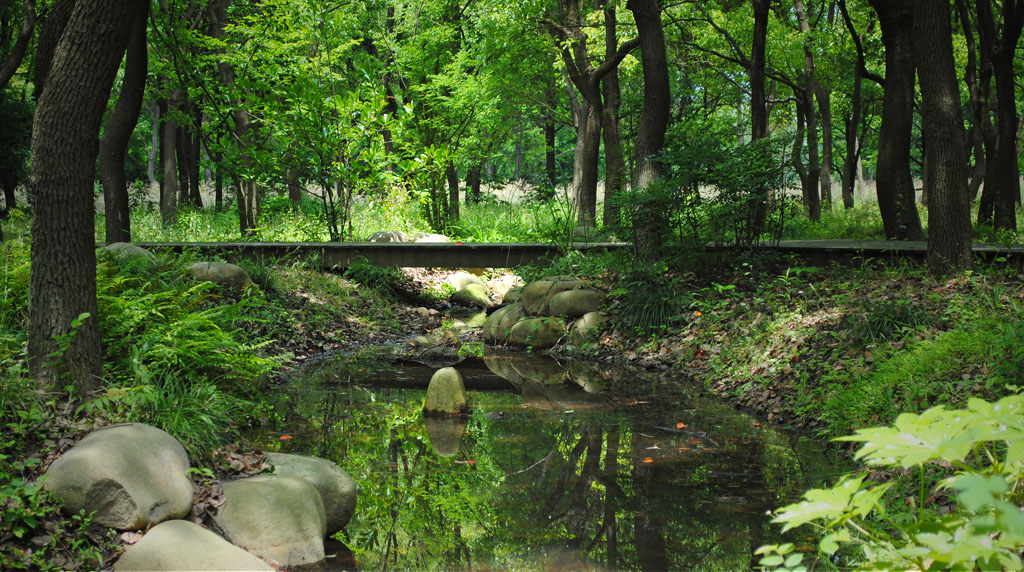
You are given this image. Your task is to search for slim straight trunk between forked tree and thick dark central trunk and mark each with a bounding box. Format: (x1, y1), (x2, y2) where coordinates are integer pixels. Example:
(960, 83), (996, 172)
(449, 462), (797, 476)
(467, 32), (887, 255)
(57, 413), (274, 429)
(601, 5), (626, 226)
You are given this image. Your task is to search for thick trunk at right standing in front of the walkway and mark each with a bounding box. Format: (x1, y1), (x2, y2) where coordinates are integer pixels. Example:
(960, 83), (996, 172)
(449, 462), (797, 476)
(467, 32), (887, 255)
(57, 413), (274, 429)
(913, 0), (970, 274)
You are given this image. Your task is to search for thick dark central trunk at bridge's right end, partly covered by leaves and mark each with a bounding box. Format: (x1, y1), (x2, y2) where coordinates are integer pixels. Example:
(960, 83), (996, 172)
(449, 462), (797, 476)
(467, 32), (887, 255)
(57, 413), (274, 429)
(626, 0), (672, 260)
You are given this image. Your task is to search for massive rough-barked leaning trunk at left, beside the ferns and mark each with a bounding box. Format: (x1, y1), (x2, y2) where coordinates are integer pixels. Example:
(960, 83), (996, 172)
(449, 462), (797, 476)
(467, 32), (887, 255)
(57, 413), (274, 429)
(29, 0), (144, 394)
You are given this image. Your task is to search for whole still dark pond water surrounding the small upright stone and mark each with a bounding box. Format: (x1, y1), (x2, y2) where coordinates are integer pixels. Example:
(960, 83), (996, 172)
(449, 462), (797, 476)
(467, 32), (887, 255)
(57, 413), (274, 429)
(256, 351), (837, 570)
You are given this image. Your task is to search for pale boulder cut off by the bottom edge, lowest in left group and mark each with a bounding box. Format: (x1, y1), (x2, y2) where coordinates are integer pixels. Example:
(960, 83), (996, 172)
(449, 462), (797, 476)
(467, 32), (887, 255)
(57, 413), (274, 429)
(114, 521), (273, 572)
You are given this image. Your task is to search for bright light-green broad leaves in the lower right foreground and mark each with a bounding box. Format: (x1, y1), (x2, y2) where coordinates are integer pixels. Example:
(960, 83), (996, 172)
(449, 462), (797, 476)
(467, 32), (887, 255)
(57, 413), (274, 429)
(762, 395), (1024, 570)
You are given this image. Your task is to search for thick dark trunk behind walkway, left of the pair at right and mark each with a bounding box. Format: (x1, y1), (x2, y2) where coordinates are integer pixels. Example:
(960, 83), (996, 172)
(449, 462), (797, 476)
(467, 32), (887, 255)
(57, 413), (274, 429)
(870, 0), (925, 240)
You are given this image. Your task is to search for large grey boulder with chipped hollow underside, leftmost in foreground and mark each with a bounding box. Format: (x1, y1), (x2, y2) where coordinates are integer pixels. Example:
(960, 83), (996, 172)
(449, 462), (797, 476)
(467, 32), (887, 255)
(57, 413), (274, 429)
(44, 424), (193, 530)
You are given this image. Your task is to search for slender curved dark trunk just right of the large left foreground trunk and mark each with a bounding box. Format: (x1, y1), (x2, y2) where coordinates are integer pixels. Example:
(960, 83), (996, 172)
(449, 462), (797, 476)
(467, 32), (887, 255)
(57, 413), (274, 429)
(99, 2), (150, 245)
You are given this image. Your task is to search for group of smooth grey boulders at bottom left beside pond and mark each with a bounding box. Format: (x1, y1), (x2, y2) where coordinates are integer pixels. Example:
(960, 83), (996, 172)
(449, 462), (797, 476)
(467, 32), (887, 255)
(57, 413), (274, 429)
(44, 424), (355, 571)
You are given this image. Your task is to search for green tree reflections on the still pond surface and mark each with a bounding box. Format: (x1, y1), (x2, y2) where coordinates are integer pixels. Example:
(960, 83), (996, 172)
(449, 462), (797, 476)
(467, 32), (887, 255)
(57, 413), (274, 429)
(264, 356), (823, 570)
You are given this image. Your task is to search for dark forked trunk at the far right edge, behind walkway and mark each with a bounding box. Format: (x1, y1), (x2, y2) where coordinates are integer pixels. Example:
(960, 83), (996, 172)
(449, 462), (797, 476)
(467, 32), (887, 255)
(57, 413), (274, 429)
(977, 0), (1024, 229)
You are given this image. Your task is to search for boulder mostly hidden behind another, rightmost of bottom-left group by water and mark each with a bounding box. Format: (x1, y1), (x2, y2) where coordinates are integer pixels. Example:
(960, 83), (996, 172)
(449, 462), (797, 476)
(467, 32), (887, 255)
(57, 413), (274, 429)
(266, 453), (355, 535)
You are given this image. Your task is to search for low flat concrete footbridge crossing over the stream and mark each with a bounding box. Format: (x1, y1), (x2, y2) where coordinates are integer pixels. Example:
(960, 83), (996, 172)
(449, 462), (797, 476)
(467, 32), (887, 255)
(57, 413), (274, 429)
(136, 240), (1024, 268)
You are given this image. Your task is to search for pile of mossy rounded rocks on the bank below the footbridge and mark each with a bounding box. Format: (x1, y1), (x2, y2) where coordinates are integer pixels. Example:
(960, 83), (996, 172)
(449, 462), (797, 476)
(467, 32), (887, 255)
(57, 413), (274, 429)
(483, 276), (607, 349)
